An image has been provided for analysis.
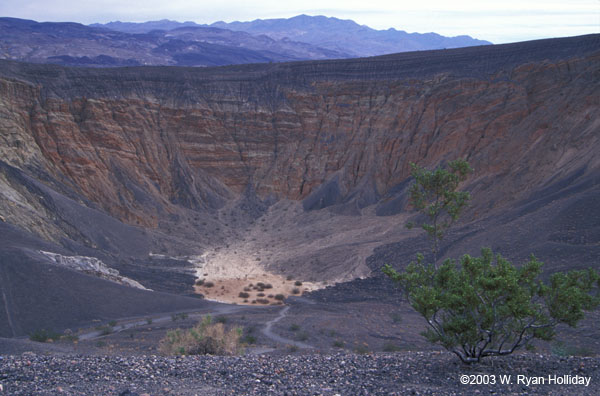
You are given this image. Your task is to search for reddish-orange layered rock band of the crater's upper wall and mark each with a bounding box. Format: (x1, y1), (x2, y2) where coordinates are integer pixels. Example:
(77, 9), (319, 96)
(0, 52), (600, 226)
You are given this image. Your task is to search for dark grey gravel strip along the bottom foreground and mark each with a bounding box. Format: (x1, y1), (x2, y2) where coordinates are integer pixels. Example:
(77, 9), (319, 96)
(0, 352), (600, 396)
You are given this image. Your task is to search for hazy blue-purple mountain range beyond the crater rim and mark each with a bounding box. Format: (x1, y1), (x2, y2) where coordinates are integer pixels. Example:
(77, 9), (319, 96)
(0, 15), (489, 67)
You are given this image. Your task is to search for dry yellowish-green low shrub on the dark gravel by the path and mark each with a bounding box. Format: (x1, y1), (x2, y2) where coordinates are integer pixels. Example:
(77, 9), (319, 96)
(159, 315), (242, 355)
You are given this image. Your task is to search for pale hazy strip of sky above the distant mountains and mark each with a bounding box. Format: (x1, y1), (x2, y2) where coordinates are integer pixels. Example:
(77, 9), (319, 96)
(0, 0), (600, 43)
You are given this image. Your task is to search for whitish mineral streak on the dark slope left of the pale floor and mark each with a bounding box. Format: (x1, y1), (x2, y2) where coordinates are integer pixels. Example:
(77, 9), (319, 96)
(40, 250), (150, 290)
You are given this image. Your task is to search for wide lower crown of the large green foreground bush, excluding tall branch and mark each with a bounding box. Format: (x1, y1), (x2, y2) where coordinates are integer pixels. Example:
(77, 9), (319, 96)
(384, 248), (600, 363)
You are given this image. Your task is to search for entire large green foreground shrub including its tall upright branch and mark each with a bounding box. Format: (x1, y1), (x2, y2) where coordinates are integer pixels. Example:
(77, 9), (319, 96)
(383, 159), (600, 364)
